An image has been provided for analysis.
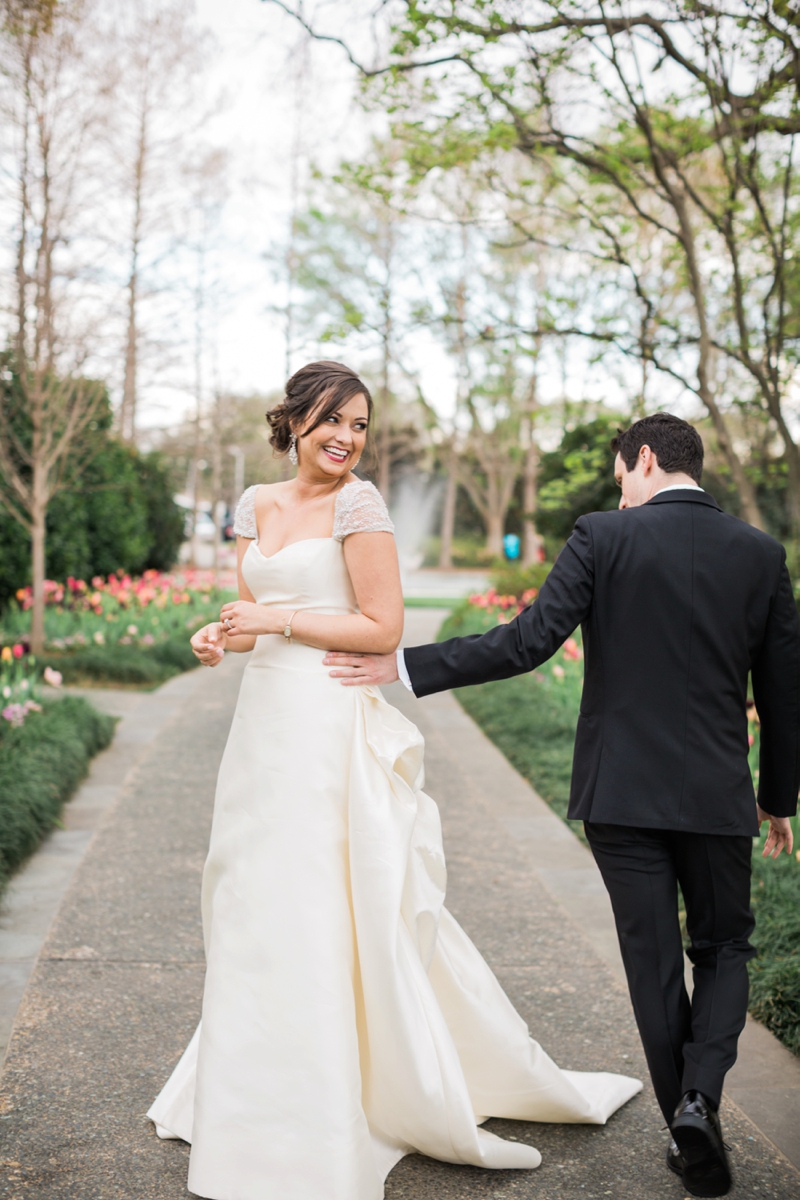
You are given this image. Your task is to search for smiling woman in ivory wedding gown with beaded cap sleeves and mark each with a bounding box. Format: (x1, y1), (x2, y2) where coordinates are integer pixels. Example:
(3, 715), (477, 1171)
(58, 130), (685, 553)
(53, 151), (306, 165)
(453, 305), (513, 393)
(149, 362), (642, 1200)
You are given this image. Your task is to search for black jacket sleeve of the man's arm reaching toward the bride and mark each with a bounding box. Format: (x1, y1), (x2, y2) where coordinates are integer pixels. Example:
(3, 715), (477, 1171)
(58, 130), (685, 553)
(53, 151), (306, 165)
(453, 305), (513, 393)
(403, 517), (594, 696)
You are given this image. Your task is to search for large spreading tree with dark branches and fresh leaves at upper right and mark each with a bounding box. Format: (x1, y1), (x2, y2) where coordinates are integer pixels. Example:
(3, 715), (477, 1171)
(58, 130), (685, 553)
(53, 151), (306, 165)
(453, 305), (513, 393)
(273, 0), (800, 528)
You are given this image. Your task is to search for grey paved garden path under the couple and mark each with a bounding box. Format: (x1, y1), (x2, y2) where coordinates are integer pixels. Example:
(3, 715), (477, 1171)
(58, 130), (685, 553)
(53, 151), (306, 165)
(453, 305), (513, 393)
(0, 610), (800, 1200)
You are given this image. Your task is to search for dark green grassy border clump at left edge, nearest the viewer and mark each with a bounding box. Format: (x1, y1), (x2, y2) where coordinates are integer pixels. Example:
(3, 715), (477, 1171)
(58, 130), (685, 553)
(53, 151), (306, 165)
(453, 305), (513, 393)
(0, 696), (115, 887)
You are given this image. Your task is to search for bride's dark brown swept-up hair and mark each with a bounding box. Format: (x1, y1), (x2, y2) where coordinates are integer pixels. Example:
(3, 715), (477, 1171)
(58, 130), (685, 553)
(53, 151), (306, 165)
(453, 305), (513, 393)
(266, 362), (373, 454)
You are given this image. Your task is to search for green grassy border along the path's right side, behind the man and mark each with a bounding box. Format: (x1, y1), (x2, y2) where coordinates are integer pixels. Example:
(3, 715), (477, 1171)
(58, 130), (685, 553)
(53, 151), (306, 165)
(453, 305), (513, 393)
(439, 602), (800, 1055)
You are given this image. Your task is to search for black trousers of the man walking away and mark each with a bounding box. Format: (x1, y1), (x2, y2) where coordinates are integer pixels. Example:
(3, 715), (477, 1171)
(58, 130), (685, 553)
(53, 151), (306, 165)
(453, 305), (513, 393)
(585, 821), (756, 1123)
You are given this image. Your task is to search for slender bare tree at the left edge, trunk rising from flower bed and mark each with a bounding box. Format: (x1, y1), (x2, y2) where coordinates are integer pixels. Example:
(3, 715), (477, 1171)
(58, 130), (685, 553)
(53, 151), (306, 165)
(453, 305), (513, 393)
(0, 0), (109, 653)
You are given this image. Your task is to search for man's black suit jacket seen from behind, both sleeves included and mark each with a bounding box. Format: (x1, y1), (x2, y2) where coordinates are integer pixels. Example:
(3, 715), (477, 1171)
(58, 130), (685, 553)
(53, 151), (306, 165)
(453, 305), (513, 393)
(405, 488), (800, 835)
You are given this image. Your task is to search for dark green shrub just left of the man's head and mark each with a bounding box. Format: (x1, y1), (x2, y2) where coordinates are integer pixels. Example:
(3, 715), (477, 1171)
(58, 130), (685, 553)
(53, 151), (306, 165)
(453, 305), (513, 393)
(536, 415), (630, 541)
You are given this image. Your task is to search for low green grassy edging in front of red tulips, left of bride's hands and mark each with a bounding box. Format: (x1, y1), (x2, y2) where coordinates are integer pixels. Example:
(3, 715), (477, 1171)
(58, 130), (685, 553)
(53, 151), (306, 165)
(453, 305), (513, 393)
(40, 634), (199, 688)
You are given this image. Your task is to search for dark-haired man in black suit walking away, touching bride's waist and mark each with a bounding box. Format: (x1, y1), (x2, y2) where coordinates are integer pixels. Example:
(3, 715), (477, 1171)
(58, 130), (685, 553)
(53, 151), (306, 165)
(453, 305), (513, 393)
(326, 413), (800, 1196)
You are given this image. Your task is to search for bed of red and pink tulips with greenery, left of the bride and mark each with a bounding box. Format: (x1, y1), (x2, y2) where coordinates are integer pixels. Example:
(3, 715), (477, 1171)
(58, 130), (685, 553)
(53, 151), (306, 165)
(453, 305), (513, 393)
(0, 570), (235, 686)
